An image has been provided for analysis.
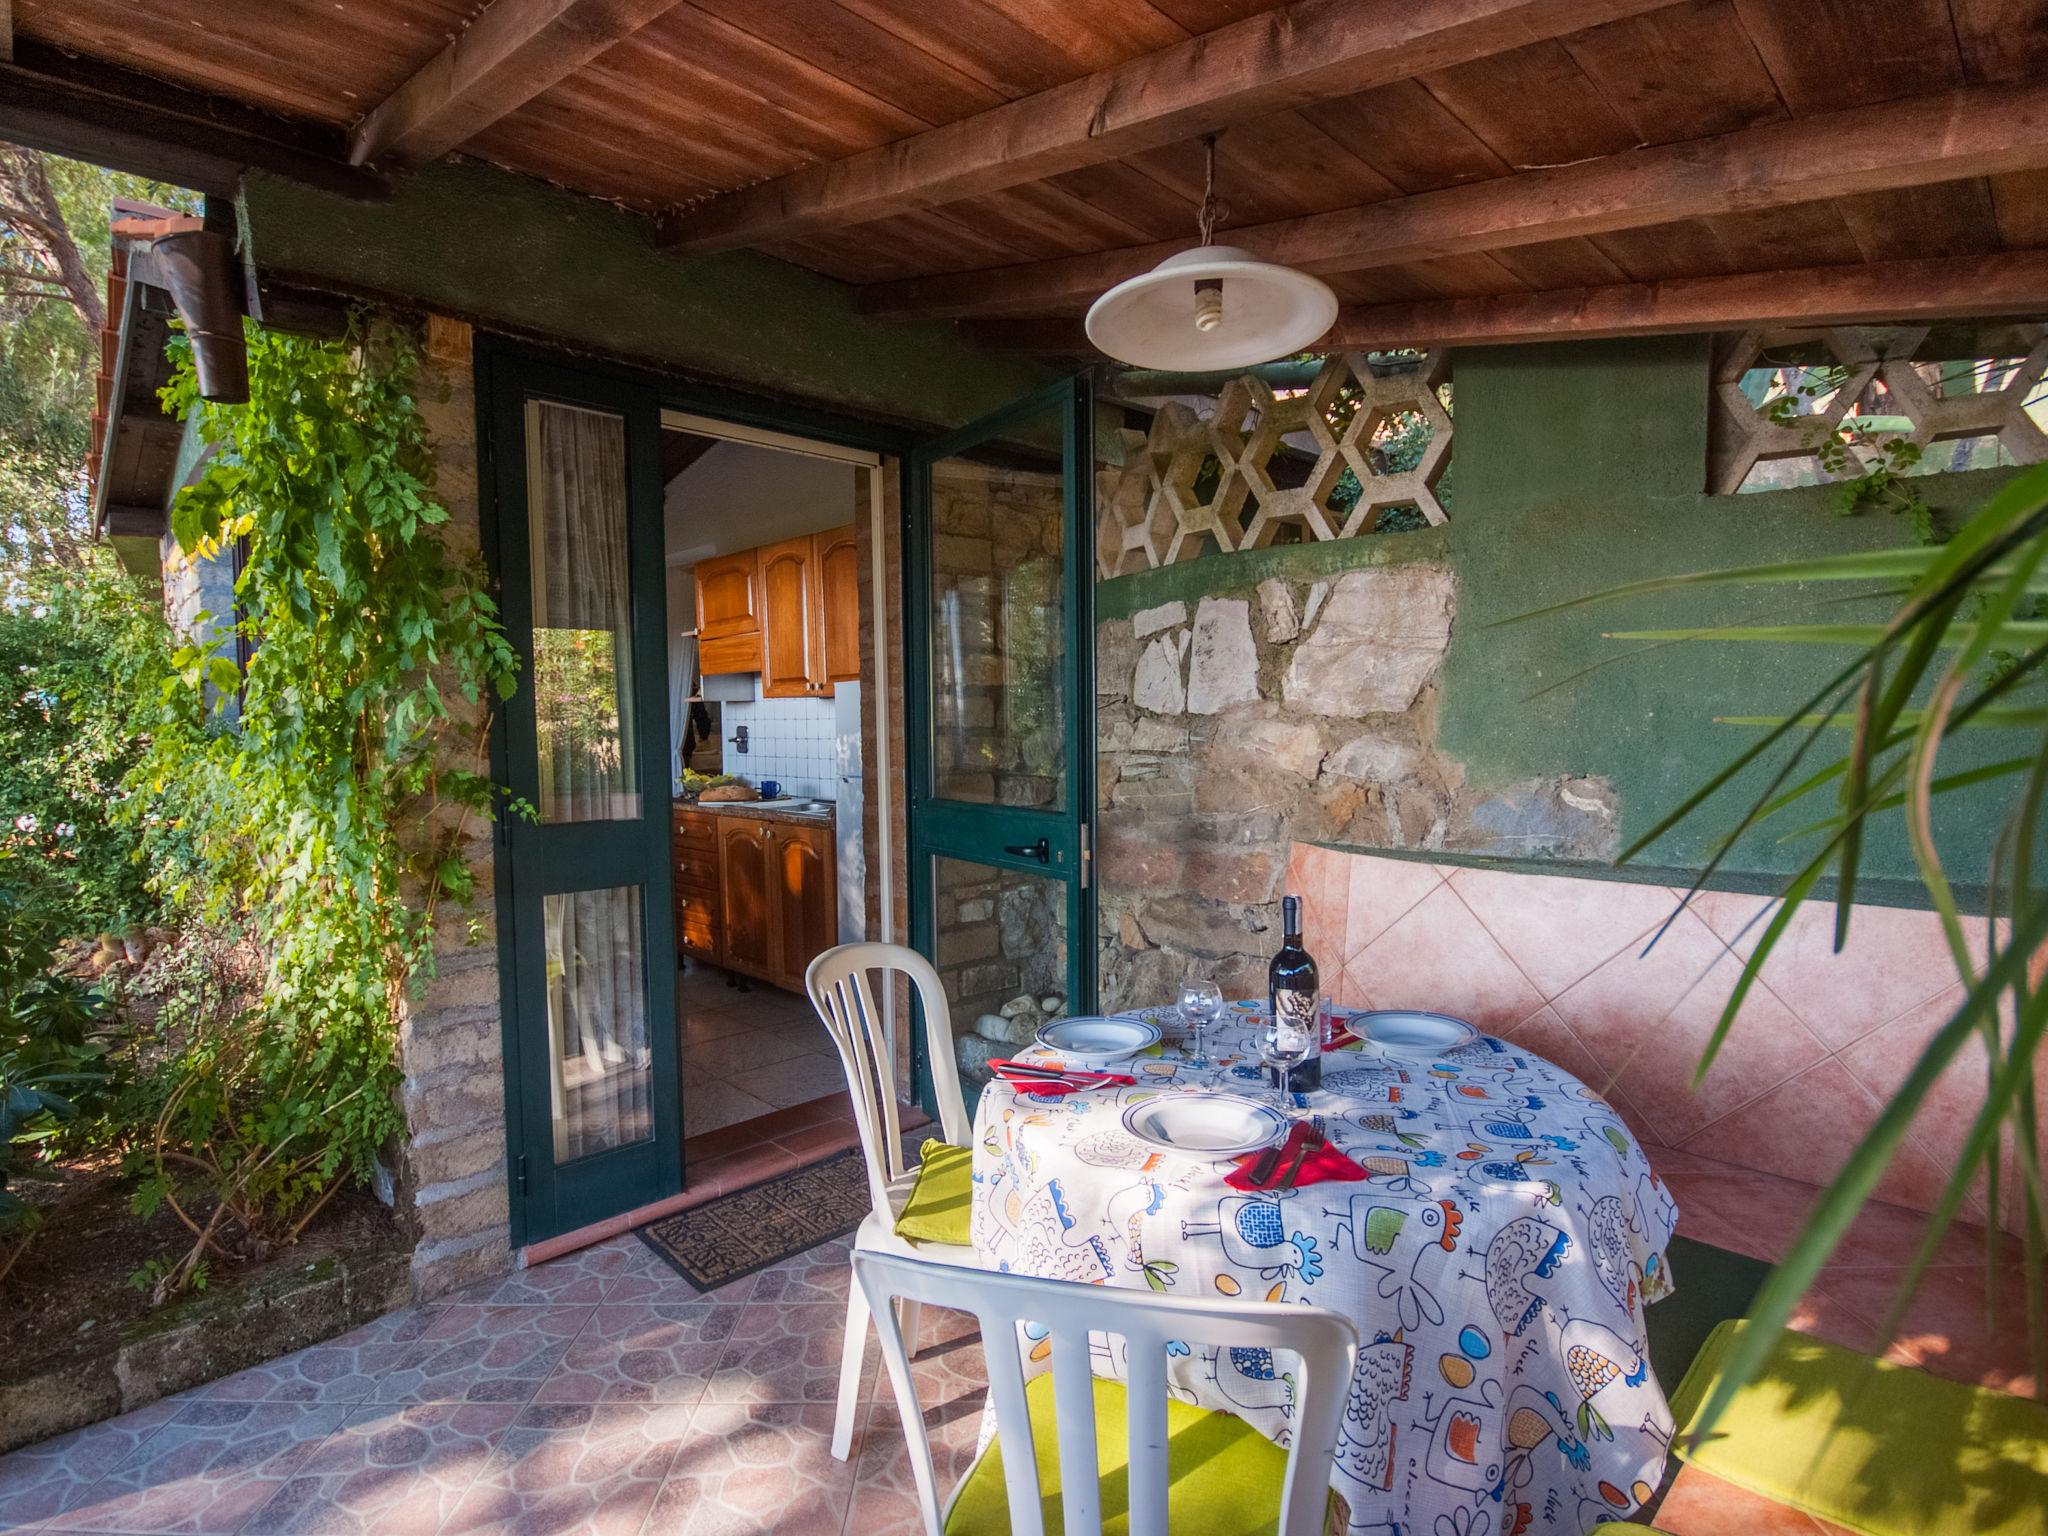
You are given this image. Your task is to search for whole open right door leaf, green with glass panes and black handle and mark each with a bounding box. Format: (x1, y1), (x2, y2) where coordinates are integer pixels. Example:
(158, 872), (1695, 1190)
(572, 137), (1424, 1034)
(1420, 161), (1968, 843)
(903, 379), (1096, 1108)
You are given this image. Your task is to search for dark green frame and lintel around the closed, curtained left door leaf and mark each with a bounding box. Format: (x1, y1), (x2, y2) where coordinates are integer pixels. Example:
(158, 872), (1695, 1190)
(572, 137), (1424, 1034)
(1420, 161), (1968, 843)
(473, 332), (922, 1247)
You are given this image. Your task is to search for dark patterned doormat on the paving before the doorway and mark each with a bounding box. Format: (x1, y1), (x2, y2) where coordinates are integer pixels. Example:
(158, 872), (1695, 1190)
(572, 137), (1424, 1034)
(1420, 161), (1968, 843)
(635, 1151), (874, 1290)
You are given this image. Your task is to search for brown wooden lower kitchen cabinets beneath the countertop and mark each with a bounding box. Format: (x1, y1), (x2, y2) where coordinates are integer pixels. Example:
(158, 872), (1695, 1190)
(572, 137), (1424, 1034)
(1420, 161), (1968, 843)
(696, 811), (840, 991)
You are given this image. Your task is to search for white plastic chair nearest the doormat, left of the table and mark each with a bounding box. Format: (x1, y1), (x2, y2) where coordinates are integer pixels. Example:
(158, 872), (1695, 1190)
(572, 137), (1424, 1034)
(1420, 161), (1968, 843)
(803, 944), (981, 1462)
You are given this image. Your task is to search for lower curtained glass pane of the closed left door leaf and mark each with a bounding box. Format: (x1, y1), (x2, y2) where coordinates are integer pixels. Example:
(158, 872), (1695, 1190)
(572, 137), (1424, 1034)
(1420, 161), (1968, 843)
(541, 885), (653, 1163)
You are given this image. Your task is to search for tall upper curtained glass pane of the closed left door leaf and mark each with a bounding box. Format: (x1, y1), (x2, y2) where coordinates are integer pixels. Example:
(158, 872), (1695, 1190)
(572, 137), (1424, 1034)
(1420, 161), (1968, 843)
(526, 399), (641, 821)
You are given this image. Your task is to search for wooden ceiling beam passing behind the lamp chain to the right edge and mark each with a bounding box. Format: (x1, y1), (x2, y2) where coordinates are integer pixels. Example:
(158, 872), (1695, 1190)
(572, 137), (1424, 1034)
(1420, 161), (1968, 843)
(860, 84), (2048, 315)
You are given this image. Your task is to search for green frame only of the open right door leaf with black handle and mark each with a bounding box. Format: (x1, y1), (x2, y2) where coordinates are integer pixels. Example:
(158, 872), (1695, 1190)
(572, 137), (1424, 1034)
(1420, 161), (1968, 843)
(903, 375), (1096, 1116)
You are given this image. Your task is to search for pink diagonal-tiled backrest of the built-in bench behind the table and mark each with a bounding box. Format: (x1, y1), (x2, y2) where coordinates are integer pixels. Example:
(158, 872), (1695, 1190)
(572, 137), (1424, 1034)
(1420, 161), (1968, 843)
(1288, 844), (2023, 1236)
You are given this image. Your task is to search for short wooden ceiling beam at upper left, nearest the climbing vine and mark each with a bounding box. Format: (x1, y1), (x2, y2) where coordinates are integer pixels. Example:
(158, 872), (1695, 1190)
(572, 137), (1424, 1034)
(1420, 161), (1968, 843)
(348, 0), (696, 166)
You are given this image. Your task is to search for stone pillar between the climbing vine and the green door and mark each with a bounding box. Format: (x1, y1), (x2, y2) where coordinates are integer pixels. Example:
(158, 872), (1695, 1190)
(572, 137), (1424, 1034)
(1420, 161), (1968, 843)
(397, 317), (512, 1298)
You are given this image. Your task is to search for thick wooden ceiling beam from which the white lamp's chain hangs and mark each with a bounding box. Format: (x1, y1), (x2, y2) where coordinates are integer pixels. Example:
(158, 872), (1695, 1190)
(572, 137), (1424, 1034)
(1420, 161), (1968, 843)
(663, 0), (1671, 252)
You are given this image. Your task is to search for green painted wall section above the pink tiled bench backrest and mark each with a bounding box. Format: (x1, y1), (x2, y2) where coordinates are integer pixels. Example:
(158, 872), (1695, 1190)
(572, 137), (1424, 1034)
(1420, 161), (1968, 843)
(1440, 338), (2023, 883)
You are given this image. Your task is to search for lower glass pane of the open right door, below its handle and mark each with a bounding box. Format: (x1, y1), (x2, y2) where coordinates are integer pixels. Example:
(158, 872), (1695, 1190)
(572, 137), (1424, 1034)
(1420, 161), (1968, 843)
(932, 858), (1067, 1038)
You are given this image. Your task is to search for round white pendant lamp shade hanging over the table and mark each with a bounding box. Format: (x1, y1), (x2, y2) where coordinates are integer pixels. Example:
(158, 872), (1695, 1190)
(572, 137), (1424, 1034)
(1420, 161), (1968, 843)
(1087, 246), (1337, 373)
